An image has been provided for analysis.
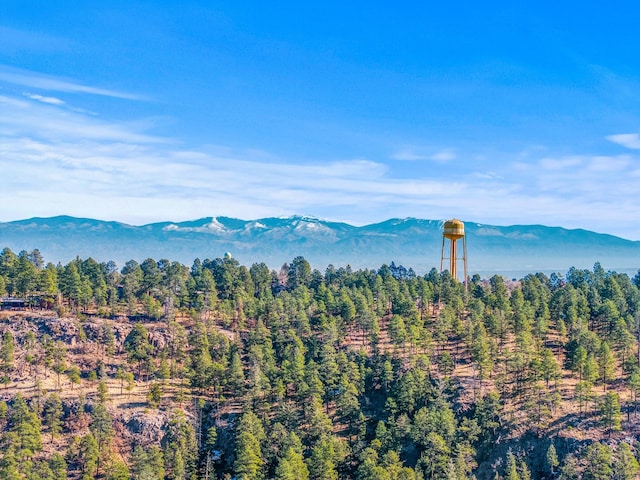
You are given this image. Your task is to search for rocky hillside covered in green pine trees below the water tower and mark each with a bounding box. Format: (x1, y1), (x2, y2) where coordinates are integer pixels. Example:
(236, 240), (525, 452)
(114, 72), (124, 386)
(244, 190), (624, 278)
(0, 248), (640, 480)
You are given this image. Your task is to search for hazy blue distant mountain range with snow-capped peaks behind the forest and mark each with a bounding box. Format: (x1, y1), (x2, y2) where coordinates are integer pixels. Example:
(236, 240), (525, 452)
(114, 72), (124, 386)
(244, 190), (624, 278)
(0, 216), (640, 277)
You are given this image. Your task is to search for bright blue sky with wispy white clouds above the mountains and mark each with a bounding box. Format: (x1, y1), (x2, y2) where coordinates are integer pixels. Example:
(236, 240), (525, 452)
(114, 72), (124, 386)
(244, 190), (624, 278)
(0, 0), (640, 240)
